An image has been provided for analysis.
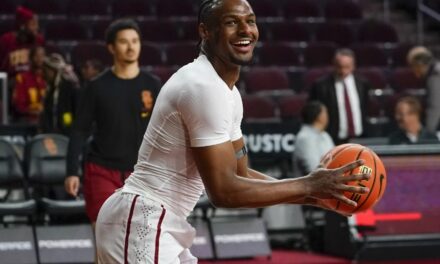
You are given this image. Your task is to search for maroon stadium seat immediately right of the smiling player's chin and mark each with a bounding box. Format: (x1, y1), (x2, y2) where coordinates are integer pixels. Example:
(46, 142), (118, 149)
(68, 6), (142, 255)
(259, 43), (300, 66)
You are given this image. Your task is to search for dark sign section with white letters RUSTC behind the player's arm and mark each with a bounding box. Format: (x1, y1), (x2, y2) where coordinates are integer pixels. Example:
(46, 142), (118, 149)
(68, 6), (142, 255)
(242, 123), (299, 157)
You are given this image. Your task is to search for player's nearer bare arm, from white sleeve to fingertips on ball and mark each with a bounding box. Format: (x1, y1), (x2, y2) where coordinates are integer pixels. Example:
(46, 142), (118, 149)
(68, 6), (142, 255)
(192, 141), (369, 208)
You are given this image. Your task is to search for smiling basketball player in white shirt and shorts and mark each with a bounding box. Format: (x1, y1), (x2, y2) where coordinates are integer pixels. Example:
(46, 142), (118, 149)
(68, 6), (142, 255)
(96, 0), (369, 264)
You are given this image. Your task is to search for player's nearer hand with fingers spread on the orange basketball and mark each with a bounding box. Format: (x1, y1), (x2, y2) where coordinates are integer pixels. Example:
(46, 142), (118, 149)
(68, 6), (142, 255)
(306, 160), (370, 206)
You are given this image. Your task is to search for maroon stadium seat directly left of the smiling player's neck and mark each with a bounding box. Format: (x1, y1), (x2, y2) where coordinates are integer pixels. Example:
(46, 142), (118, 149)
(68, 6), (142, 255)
(166, 42), (199, 66)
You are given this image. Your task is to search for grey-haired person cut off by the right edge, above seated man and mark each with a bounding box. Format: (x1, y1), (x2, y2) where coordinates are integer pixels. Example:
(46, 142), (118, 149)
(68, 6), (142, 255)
(407, 46), (440, 133)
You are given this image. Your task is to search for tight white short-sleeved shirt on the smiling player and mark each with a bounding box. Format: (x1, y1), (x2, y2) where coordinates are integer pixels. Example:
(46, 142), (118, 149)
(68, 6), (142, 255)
(123, 55), (243, 217)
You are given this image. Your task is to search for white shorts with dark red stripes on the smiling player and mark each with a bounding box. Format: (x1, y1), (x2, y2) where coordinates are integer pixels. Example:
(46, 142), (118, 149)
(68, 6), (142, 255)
(96, 191), (197, 264)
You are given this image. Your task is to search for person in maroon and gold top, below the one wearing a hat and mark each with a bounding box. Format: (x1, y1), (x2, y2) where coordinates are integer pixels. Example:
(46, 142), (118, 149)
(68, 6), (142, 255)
(12, 46), (46, 124)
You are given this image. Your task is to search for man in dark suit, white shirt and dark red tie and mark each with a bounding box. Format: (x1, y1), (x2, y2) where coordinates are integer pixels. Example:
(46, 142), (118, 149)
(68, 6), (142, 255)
(309, 49), (370, 144)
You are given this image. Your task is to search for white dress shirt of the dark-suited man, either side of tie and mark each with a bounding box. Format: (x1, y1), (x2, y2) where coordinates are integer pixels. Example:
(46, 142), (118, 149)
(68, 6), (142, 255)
(335, 74), (363, 139)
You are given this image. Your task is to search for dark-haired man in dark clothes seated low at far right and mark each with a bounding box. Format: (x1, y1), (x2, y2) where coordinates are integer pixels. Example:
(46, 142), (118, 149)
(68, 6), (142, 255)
(388, 96), (439, 145)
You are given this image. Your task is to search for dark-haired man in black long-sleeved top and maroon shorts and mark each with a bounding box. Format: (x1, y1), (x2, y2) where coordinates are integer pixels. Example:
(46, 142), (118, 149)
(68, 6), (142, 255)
(65, 19), (160, 225)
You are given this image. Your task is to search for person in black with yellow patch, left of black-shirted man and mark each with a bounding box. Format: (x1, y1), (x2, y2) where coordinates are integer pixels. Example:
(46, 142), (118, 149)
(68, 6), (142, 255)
(40, 53), (79, 136)
